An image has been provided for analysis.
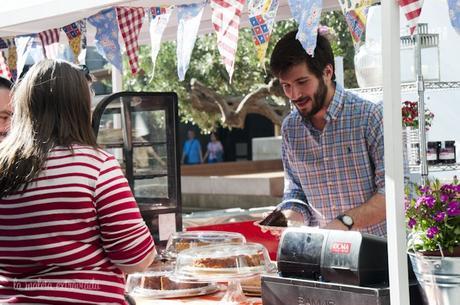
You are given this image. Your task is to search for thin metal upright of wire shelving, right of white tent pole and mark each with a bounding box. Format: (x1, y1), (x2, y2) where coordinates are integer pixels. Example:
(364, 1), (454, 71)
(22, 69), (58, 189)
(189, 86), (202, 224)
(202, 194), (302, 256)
(415, 24), (428, 185)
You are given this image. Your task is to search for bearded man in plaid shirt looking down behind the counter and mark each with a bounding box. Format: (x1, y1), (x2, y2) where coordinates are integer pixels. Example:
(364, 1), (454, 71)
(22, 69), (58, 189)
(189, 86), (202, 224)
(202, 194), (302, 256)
(270, 31), (386, 236)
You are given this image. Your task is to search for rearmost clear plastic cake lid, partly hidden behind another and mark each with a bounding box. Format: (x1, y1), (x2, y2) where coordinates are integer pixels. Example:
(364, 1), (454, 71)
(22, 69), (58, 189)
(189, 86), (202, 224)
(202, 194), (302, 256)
(165, 231), (246, 258)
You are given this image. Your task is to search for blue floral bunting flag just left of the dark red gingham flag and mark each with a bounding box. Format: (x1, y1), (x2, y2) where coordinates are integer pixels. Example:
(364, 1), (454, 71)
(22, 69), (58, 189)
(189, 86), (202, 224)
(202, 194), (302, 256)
(88, 8), (122, 71)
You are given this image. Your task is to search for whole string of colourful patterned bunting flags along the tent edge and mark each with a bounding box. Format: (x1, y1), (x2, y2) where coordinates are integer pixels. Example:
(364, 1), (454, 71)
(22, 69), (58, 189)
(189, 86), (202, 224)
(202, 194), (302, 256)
(0, 0), (434, 81)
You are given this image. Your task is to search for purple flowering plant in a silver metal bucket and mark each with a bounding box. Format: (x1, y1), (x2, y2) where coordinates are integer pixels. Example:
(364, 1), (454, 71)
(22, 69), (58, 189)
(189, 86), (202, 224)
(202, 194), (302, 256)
(406, 178), (460, 305)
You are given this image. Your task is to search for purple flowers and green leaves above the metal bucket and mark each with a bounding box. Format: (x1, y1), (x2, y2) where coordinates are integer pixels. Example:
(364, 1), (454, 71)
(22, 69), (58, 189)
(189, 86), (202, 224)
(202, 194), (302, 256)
(406, 178), (460, 255)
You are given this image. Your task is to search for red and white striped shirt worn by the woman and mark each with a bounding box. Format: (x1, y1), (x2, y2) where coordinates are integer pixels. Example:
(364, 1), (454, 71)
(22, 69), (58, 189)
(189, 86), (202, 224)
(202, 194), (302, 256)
(0, 145), (153, 305)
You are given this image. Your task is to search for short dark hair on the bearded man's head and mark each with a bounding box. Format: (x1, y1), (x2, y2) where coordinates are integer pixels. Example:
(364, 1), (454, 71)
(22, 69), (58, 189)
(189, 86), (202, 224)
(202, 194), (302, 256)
(270, 30), (335, 80)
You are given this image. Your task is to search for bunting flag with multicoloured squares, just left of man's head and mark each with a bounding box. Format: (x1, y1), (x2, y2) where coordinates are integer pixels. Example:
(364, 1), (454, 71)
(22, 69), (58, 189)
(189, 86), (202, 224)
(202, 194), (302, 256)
(248, 0), (279, 63)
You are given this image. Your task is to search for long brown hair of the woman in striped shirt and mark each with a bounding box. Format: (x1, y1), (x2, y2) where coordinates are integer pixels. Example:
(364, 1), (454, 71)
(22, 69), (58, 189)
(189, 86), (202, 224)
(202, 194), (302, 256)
(0, 59), (97, 198)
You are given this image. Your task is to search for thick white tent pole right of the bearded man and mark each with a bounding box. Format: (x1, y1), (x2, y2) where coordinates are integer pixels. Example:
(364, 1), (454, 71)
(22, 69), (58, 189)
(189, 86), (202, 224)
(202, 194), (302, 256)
(381, 1), (409, 305)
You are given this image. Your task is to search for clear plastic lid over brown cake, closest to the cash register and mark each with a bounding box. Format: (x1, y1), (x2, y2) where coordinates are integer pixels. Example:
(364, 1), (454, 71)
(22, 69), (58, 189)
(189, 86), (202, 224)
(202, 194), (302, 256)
(174, 243), (273, 281)
